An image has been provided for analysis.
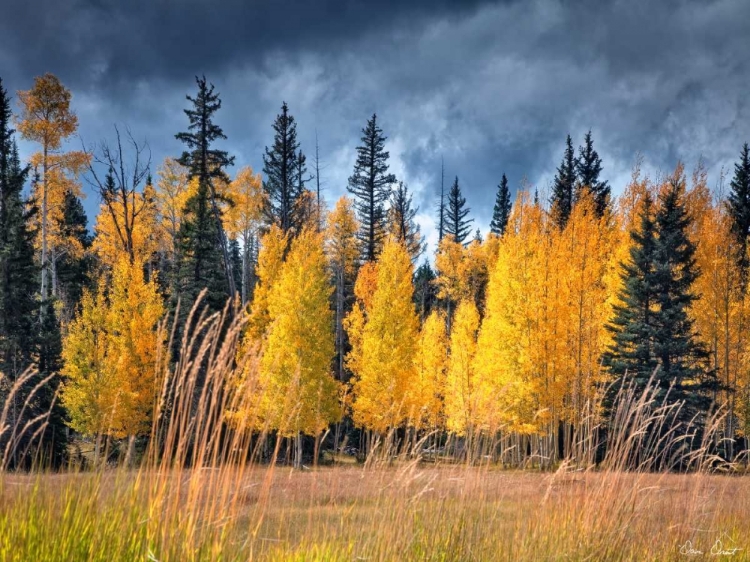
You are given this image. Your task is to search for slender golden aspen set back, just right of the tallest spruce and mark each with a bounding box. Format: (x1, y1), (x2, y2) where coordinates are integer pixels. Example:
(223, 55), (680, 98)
(224, 166), (265, 305)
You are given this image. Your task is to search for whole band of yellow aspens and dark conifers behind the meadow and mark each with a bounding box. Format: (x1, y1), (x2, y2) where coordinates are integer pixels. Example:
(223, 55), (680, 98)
(0, 75), (750, 466)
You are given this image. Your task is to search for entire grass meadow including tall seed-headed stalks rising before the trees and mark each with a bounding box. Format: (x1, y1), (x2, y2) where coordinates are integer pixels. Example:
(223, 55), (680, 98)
(0, 296), (750, 561)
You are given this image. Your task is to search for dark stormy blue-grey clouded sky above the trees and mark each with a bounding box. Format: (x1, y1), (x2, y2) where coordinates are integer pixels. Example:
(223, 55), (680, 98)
(0, 0), (750, 254)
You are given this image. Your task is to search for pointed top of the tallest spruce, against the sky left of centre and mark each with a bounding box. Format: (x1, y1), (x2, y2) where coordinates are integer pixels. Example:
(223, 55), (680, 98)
(175, 76), (234, 184)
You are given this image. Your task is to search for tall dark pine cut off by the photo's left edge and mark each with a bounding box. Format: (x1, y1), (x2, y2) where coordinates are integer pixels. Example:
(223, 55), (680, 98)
(0, 81), (67, 468)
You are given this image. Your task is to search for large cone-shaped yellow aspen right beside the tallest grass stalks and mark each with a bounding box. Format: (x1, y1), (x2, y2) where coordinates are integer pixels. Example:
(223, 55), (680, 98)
(259, 228), (341, 464)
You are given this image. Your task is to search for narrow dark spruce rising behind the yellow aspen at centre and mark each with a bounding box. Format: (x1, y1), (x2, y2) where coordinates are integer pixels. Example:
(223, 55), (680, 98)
(348, 114), (396, 261)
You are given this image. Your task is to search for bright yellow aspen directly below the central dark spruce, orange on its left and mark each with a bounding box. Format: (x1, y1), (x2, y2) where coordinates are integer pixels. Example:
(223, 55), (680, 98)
(349, 236), (419, 434)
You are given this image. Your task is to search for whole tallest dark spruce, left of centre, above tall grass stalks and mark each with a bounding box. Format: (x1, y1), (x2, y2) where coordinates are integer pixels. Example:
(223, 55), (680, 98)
(175, 76), (235, 307)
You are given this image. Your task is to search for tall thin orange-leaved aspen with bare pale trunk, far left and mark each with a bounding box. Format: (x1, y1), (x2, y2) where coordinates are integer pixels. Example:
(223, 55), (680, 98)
(18, 74), (90, 302)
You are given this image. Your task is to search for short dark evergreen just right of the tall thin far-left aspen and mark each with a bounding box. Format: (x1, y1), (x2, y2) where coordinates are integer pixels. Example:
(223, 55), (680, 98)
(55, 190), (94, 323)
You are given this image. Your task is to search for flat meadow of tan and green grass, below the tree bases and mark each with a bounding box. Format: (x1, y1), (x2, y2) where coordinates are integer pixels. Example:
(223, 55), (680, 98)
(0, 462), (750, 561)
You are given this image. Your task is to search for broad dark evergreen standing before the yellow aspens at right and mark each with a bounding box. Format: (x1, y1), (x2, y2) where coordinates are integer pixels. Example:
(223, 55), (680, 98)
(604, 171), (718, 428)
